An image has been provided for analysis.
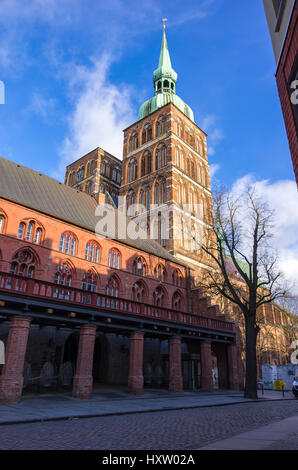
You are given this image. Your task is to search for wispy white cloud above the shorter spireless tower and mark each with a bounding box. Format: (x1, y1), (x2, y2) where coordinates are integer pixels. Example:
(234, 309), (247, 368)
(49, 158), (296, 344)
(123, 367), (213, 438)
(55, 54), (136, 178)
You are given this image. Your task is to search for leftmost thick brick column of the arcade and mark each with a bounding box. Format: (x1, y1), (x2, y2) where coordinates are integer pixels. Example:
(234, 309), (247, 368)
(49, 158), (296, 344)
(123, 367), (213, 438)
(0, 317), (31, 403)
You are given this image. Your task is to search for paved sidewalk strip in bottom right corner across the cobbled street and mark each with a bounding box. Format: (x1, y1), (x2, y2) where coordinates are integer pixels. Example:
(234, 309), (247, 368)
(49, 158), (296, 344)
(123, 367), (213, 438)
(198, 415), (298, 450)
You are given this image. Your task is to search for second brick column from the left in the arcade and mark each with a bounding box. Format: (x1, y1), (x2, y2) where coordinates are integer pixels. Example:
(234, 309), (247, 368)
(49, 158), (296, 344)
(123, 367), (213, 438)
(72, 325), (96, 399)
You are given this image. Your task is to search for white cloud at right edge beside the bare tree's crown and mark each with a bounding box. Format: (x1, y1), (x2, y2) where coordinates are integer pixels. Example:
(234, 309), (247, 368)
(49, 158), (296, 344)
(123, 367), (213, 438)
(232, 175), (298, 295)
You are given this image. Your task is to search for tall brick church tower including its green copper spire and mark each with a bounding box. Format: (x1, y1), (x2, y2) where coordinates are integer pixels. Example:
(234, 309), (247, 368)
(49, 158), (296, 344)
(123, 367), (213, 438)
(120, 26), (212, 278)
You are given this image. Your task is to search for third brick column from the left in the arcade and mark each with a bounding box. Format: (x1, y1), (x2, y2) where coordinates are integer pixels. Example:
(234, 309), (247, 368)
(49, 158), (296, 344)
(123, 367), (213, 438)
(128, 331), (144, 395)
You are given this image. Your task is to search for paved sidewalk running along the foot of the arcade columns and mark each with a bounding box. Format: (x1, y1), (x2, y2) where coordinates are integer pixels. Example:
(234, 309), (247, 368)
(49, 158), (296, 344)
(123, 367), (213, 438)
(0, 386), (293, 425)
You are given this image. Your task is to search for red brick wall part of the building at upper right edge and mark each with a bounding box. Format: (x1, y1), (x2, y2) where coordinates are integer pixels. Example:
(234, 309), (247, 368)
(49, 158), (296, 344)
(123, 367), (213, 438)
(276, 1), (298, 185)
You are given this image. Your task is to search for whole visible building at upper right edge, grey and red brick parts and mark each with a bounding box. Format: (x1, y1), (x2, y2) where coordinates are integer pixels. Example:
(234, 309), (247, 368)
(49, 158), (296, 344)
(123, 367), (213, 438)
(263, 0), (298, 184)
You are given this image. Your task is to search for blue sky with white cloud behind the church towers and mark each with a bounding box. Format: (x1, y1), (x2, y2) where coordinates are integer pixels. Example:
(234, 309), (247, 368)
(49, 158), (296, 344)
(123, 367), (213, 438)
(0, 0), (298, 290)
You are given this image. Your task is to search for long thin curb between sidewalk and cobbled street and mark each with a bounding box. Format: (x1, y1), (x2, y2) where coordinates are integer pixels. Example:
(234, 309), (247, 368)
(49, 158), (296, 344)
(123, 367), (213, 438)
(0, 398), (295, 426)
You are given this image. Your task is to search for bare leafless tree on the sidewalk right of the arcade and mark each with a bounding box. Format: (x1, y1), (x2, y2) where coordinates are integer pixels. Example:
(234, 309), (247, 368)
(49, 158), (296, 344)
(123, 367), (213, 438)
(192, 187), (286, 398)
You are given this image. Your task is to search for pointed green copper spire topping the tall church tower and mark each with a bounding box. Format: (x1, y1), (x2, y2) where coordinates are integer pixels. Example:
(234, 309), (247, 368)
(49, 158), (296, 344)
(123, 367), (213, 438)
(139, 25), (194, 121)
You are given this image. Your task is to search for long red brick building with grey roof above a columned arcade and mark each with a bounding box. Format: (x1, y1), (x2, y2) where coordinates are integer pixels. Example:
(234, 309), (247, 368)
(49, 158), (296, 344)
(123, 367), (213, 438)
(0, 158), (238, 402)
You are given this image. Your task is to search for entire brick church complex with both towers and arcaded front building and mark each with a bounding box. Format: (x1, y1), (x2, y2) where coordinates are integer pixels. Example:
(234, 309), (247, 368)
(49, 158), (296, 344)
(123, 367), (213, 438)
(0, 29), (288, 403)
